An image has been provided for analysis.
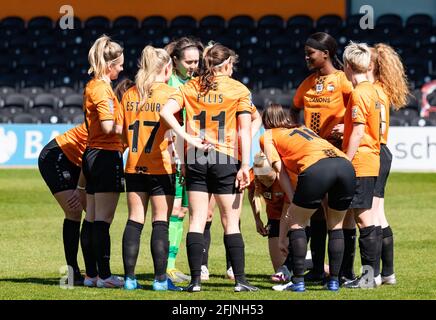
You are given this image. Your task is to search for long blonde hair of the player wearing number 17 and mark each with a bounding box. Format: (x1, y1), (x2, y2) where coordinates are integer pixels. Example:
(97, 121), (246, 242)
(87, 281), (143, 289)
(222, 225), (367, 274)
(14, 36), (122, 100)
(135, 46), (171, 105)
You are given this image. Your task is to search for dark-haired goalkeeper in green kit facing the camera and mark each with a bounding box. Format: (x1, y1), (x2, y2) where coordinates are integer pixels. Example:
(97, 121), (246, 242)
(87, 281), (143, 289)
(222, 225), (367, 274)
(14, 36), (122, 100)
(165, 37), (203, 282)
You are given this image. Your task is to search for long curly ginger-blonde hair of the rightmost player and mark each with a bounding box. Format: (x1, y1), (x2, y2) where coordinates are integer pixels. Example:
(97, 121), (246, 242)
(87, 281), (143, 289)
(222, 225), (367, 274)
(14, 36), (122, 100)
(371, 43), (410, 110)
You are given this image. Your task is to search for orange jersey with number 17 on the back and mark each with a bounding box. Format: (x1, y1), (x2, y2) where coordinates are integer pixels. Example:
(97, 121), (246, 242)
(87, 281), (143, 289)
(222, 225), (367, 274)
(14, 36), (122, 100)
(117, 83), (176, 174)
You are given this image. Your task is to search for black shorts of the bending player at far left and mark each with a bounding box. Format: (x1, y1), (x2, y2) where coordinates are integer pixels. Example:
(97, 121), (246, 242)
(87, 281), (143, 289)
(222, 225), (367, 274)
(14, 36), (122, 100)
(38, 139), (80, 194)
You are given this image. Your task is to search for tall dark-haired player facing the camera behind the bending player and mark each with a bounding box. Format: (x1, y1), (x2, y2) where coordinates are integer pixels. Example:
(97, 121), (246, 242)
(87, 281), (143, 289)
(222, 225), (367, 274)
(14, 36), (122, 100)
(293, 32), (355, 281)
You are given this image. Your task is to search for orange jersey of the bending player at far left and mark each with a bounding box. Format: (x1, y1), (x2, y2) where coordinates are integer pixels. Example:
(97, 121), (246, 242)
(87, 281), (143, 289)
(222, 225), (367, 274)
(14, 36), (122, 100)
(55, 123), (88, 167)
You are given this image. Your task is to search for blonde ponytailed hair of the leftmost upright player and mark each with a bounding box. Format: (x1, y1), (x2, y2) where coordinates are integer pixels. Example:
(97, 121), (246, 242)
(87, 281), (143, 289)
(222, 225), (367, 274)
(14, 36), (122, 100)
(88, 35), (123, 78)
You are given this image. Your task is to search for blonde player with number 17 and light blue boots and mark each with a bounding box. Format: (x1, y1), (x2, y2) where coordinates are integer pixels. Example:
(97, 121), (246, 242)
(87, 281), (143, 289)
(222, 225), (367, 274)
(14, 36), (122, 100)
(116, 46), (181, 291)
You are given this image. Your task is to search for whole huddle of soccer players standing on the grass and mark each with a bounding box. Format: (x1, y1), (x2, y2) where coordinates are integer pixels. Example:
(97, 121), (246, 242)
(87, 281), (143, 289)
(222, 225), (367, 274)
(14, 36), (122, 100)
(39, 28), (409, 292)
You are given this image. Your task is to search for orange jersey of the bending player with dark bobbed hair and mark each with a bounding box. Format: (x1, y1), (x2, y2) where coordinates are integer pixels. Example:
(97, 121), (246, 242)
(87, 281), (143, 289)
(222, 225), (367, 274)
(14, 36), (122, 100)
(262, 127), (346, 180)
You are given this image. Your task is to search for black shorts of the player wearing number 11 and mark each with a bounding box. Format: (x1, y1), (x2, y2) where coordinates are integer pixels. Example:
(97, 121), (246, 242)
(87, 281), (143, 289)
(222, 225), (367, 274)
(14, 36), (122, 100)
(186, 151), (240, 194)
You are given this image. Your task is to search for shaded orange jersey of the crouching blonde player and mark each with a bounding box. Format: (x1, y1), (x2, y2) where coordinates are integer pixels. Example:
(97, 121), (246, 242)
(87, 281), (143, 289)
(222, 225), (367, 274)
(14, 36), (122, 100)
(255, 179), (287, 219)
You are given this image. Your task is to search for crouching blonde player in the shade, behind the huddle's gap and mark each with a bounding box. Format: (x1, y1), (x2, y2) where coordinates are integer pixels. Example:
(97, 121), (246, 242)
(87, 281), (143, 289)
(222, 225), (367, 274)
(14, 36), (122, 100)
(248, 152), (291, 282)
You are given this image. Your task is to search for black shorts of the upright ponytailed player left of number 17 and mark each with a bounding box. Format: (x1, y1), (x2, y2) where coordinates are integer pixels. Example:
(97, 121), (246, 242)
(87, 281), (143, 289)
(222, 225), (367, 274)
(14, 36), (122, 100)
(82, 148), (124, 194)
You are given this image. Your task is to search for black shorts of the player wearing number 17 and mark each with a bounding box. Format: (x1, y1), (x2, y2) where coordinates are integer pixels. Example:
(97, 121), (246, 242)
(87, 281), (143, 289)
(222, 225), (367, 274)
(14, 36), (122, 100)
(126, 173), (176, 196)
